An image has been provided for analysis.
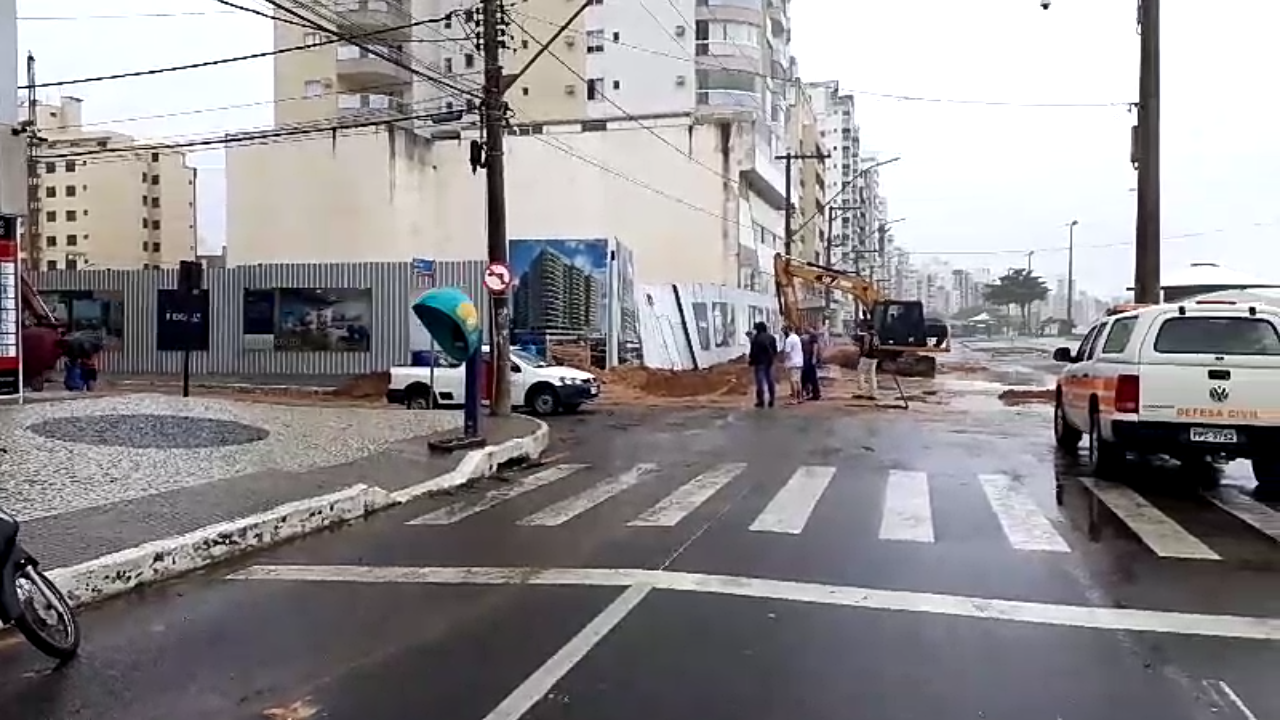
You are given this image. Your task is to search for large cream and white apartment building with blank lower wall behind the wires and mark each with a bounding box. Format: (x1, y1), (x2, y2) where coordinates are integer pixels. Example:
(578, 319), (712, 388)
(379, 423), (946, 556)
(227, 0), (799, 288)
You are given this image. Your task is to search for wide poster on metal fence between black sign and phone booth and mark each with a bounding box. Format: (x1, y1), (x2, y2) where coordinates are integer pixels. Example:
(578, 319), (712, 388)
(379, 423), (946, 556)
(243, 288), (372, 352)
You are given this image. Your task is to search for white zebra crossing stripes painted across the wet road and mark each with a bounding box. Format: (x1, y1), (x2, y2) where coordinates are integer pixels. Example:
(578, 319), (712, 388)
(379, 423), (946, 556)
(407, 462), (1280, 561)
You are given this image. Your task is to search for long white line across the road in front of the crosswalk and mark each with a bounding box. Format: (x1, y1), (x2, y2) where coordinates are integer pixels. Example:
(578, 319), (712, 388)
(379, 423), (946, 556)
(230, 565), (1280, 641)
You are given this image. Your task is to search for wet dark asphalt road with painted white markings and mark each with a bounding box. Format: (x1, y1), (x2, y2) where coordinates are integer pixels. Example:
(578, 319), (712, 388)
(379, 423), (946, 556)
(0, 351), (1280, 720)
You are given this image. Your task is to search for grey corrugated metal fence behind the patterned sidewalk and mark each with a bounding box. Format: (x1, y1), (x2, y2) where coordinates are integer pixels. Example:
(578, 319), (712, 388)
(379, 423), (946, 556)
(32, 260), (489, 377)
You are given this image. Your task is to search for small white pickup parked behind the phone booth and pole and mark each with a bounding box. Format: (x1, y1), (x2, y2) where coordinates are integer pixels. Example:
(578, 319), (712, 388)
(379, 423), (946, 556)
(387, 346), (600, 415)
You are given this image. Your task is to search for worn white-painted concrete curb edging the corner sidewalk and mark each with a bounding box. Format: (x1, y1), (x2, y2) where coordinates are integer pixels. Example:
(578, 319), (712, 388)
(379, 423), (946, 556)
(49, 420), (550, 607)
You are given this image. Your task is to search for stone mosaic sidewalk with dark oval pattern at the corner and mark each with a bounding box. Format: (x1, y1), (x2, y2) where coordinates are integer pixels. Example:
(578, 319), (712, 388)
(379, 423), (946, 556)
(0, 395), (543, 568)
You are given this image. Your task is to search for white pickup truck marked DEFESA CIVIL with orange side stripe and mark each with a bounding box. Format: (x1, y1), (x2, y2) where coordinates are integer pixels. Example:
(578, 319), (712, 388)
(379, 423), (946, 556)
(1053, 300), (1280, 492)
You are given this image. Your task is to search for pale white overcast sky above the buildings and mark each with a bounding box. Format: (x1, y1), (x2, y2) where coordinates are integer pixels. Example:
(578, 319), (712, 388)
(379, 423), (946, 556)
(18, 0), (1280, 295)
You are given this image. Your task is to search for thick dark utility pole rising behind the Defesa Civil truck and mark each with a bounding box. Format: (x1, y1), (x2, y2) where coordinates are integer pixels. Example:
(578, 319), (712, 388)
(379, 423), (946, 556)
(1133, 0), (1160, 304)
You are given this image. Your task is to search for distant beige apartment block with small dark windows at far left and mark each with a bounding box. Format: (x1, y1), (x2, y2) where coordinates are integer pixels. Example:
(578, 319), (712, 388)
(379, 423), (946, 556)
(24, 97), (196, 270)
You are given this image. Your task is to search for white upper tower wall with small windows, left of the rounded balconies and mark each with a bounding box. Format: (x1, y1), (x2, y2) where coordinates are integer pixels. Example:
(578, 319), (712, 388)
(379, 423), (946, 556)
(586, 0), (695, 118)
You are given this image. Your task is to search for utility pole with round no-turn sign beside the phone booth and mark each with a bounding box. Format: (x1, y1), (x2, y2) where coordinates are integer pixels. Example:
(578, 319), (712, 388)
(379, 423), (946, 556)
(480, 0), (511, 415)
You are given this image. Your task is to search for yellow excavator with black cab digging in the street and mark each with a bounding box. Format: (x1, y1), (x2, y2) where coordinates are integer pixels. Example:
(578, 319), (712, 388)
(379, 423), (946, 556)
(773, 252), (951, 378)
